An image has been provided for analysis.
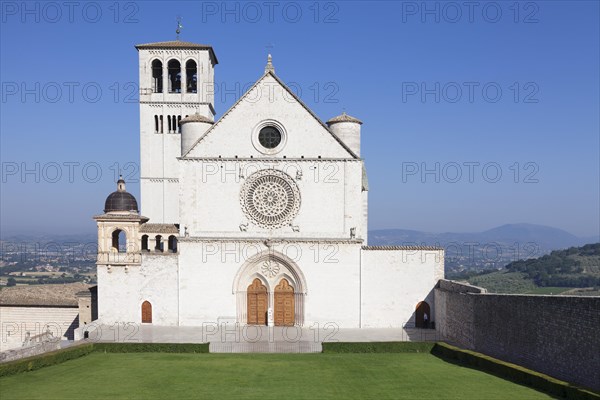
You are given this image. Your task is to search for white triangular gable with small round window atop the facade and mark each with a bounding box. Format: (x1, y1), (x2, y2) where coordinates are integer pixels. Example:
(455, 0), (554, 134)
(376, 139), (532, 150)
(183, 71), (358, 159)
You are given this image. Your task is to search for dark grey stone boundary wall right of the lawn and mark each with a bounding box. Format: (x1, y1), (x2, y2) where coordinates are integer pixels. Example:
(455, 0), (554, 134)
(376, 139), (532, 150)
(435, 280), (600, 390)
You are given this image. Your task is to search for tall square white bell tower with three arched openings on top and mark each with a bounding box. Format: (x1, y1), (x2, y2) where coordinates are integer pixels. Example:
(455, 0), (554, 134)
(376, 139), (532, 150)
(135, 40), (218, 224)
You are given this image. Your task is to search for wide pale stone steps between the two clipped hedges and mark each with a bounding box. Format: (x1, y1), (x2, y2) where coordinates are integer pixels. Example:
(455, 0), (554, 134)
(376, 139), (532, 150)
(208, 341), (323, 353)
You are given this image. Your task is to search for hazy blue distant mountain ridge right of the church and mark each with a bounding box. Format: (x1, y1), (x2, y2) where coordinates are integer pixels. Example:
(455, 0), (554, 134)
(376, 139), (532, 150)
(369, 224), (600, 252)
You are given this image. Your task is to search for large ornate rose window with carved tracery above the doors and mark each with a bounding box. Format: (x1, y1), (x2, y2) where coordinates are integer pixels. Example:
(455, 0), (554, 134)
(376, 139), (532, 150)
(240, 170), (300, 229)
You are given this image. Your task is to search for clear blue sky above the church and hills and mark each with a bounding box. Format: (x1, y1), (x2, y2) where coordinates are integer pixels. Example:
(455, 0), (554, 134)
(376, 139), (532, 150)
(0, 1), (600, 236)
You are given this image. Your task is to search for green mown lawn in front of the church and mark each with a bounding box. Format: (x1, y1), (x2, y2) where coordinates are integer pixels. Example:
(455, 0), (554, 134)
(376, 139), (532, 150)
(0, 353), (551, 400)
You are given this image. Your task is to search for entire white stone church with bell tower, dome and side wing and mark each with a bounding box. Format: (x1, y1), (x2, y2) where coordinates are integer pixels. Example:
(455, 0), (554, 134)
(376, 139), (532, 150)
(94, 41), (444, 328)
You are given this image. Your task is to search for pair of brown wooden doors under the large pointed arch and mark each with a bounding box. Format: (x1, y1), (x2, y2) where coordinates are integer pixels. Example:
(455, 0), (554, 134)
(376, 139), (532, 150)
(247, 278), (295, 326)
